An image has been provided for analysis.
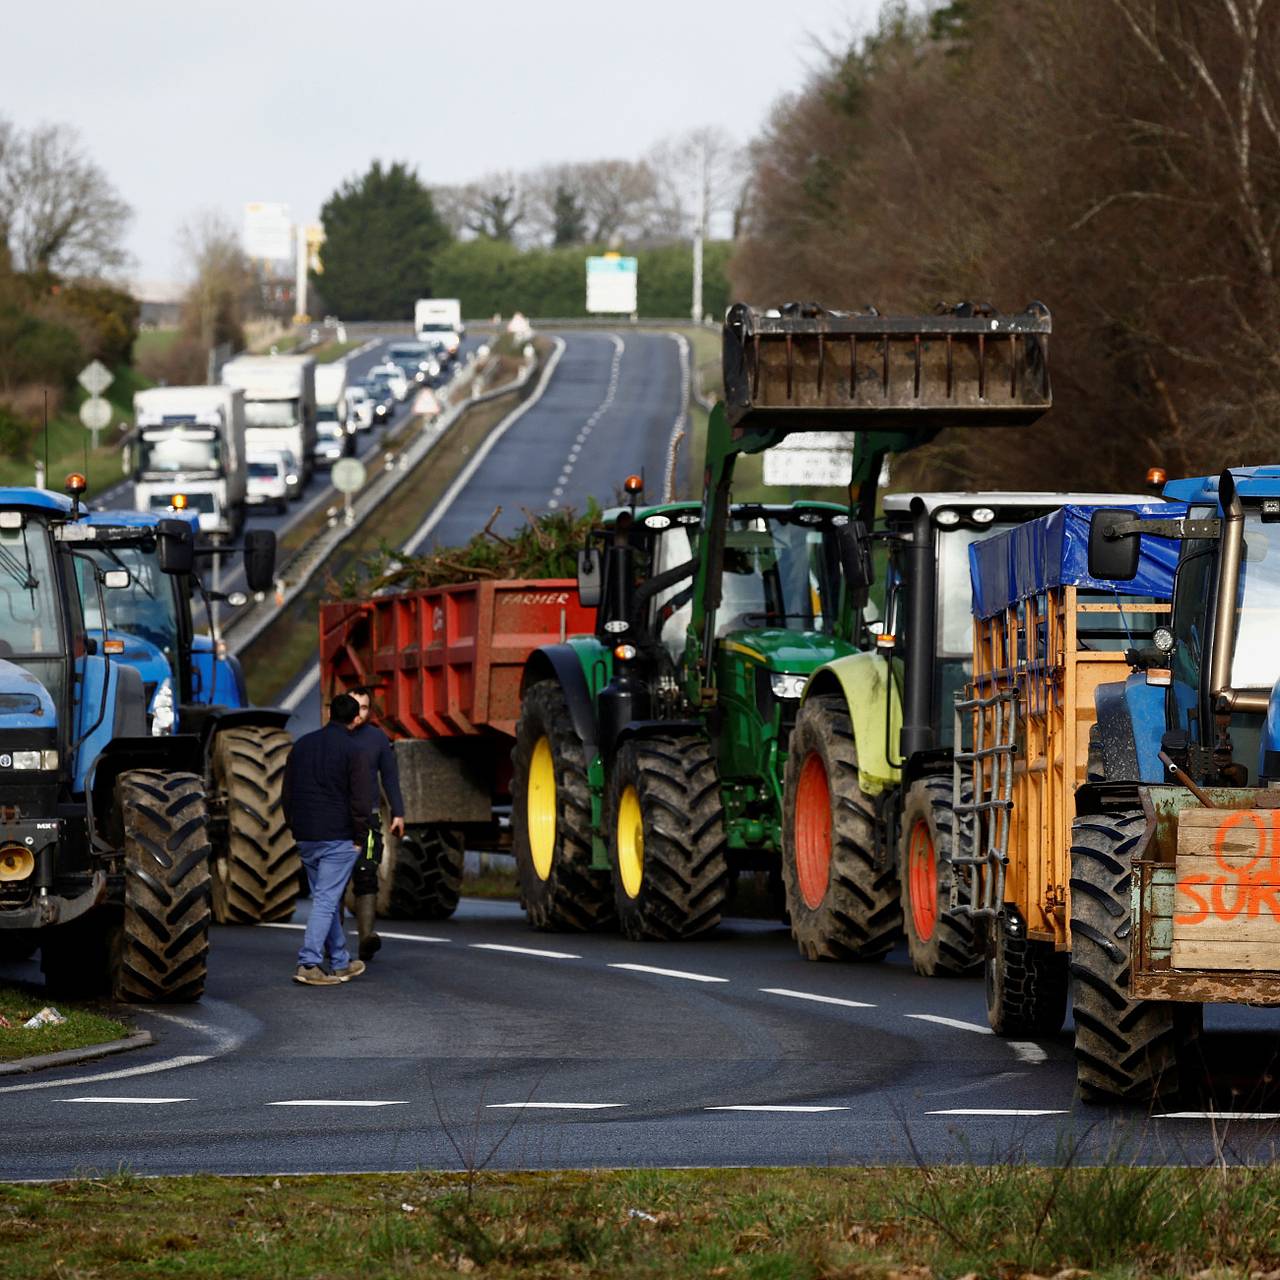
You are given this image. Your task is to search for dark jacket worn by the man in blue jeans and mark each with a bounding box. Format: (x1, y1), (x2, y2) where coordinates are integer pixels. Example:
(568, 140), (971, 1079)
(282, 723), (374, 849)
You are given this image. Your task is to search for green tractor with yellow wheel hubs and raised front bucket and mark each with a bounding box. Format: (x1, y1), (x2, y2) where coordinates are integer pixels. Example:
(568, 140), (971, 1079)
(512, 305), (1050, 940)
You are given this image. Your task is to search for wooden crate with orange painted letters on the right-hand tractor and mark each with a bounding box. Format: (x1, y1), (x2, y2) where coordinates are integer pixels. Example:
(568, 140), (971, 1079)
(1172, 808), (1280, 973)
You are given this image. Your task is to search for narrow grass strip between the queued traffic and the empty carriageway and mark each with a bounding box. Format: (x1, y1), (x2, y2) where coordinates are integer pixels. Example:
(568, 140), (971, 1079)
(241, 350), (538, 705)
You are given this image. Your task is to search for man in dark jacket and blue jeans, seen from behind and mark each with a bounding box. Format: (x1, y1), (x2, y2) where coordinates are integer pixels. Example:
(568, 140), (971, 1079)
(283, 694), (374, 987)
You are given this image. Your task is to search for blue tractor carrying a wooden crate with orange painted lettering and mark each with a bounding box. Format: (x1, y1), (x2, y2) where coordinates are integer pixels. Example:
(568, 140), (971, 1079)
(1071, 466), (1280, 1100)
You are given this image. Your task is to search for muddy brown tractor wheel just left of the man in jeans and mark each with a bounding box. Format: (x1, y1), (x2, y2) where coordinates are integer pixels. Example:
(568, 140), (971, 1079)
(212, 724), (301, 924)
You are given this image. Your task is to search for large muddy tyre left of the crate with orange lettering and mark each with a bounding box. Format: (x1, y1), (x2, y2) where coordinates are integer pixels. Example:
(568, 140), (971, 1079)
(1071, 809), (1201, 1102)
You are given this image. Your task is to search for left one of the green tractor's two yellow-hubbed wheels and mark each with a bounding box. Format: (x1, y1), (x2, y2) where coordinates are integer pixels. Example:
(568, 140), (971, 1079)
(511, 680), (614, 932)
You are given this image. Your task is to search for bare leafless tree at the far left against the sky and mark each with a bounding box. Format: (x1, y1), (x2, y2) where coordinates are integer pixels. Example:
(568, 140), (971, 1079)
(0, 120), (132, 276)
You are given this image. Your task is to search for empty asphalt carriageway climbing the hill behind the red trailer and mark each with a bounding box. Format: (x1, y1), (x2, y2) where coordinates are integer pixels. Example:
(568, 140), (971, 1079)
(276, 325), (684, 736)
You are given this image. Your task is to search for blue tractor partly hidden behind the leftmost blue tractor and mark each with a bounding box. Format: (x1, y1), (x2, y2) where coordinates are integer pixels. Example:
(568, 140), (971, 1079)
(74, 511), (301, 924)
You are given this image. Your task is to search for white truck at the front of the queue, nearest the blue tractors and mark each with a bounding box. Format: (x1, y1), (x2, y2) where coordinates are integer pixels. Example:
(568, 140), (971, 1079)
(128, 387), (247, 539)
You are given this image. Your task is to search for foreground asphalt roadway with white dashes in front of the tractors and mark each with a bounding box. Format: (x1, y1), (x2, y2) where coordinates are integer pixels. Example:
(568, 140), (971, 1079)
(0, 901), (1280, 1179)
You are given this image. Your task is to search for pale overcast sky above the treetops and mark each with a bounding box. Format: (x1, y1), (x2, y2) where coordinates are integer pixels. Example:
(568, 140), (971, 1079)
(0, 0), (879, 279)
